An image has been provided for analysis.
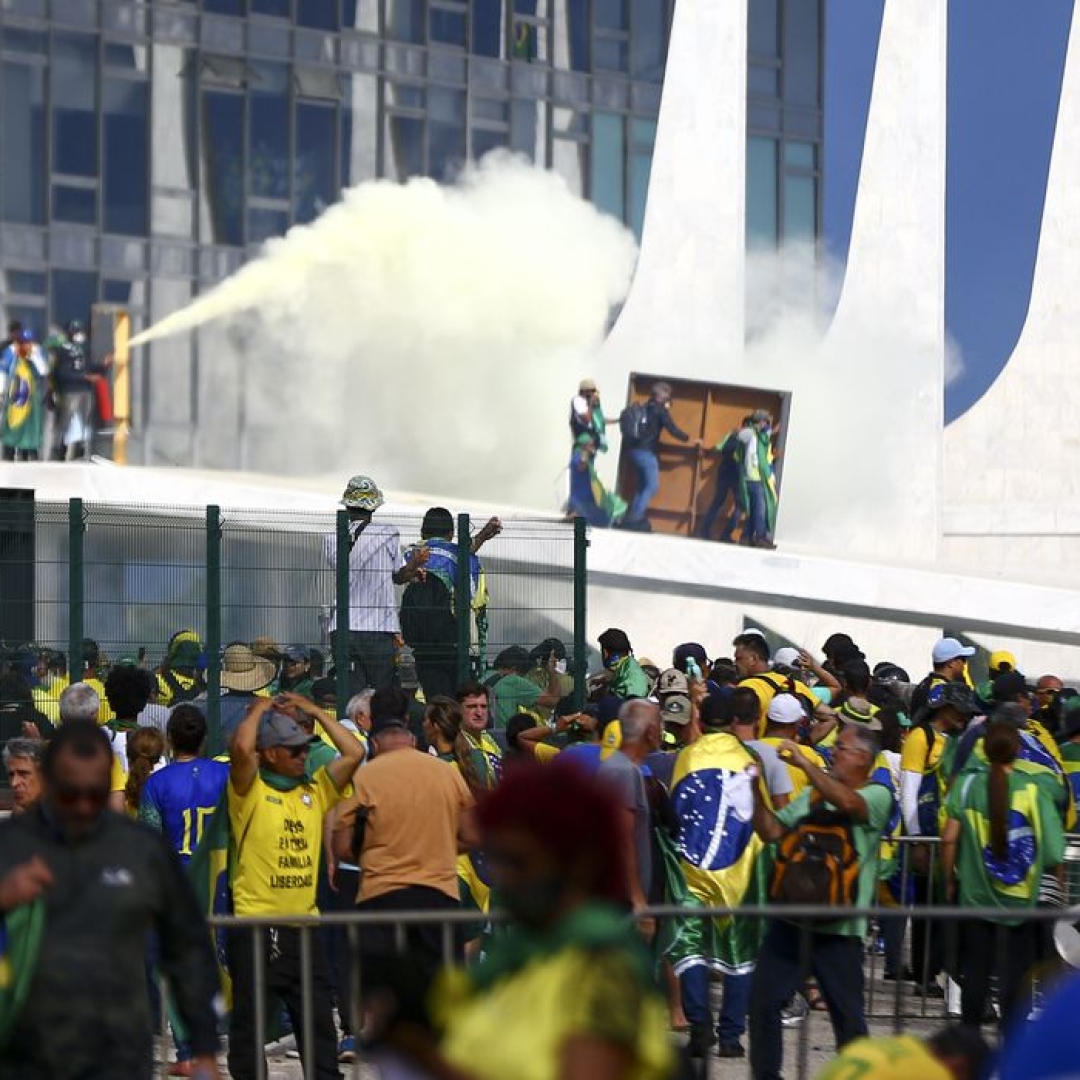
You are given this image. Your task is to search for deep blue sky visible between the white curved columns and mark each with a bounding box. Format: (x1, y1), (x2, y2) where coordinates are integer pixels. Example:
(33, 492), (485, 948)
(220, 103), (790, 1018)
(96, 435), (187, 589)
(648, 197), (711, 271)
(823, 0), (1072, 420)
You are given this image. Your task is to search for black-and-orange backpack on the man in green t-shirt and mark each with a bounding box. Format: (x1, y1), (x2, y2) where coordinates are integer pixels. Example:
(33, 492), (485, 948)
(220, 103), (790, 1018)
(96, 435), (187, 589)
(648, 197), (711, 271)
(769, 800), (859, 907)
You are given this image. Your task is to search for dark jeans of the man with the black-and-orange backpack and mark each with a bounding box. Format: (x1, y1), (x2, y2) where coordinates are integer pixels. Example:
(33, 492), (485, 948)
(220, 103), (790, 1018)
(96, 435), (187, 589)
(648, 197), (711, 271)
(750, 919), (866, 1080)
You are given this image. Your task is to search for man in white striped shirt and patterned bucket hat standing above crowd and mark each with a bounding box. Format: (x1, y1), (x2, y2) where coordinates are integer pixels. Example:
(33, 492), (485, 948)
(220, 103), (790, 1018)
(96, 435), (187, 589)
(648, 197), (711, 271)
(324, 476), (401, 693)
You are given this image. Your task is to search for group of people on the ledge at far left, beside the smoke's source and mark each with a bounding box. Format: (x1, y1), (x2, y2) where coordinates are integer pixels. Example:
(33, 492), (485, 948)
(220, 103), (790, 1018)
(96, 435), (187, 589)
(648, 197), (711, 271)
(0, 320), (112, 461)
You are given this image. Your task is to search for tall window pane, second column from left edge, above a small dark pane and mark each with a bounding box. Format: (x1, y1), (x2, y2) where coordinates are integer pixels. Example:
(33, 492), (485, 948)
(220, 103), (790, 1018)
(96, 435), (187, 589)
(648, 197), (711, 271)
(50, 33), (97, 176)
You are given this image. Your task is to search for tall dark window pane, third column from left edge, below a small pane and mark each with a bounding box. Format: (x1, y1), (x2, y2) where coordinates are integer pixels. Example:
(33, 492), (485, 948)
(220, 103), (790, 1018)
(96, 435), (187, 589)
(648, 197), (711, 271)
(103, 79), (149, 237)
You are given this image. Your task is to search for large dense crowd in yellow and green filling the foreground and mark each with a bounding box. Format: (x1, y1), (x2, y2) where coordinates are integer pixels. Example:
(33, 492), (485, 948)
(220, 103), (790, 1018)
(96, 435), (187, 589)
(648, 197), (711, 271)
(0, 477), (1080, 1080)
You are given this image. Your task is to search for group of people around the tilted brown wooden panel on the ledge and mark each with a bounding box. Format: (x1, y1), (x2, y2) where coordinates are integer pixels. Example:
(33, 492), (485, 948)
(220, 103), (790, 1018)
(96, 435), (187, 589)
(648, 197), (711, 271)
(567, 379), (780, 549)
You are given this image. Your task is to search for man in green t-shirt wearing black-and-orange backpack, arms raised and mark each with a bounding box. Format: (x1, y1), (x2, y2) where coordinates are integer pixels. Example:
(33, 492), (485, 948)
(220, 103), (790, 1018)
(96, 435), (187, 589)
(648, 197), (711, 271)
(750, 725), (893, 1080)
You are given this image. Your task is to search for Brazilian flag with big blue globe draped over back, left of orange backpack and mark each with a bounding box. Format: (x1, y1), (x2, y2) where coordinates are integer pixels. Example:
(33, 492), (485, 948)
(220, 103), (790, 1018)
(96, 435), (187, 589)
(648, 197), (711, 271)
(672, 732), (768, 974)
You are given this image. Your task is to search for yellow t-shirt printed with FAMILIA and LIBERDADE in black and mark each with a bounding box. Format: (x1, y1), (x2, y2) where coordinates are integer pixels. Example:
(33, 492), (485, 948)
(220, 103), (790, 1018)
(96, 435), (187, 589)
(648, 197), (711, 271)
(227, 768), (351, 915)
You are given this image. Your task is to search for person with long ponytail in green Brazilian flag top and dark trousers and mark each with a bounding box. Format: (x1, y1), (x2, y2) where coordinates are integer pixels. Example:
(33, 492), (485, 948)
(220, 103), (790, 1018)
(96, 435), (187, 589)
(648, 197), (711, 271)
(942, 720), (1065, 1030)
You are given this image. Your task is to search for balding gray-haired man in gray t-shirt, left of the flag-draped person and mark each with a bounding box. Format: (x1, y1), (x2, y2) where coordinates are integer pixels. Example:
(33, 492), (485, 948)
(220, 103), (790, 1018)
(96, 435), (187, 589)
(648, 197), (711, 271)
(596, 698), (663, 936)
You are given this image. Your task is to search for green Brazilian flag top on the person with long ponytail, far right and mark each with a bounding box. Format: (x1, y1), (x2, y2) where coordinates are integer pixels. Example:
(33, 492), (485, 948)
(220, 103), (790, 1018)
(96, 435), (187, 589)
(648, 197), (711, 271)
(945, 771), (1065, 924)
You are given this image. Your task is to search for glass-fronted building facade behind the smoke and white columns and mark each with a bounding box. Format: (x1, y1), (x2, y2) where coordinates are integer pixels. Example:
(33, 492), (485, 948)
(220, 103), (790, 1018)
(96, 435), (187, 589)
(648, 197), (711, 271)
(0, 0), (823, 464)
